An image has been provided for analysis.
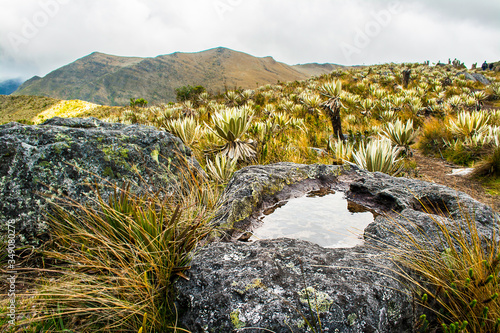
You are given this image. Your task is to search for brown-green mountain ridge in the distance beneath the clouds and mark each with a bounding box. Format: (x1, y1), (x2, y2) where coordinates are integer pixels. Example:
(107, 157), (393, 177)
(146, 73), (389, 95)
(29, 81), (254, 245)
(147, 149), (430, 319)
(13, 47), (340, 105)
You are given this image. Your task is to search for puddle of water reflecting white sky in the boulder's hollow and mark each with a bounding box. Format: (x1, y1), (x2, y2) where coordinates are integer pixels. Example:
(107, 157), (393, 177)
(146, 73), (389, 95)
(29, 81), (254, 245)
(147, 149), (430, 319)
(250, 190), (374, 248)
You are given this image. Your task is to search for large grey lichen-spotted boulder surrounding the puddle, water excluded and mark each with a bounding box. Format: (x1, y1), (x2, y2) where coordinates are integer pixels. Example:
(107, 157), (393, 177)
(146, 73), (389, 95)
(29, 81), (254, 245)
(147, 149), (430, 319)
(176, 163), (498, 332)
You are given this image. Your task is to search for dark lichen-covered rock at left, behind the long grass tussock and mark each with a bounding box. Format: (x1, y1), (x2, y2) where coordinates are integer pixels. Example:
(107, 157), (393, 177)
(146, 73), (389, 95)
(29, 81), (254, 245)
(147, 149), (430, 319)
(0, 118), (197, 247)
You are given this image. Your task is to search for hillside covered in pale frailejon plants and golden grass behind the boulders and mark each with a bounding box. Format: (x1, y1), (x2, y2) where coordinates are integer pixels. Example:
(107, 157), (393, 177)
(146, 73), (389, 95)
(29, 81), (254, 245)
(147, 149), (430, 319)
(102, 64), (500, 185)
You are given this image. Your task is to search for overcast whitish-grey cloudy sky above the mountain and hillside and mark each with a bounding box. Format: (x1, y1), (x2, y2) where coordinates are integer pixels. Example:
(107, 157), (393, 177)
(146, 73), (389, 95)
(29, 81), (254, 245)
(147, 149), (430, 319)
(0, 0), (500, 81)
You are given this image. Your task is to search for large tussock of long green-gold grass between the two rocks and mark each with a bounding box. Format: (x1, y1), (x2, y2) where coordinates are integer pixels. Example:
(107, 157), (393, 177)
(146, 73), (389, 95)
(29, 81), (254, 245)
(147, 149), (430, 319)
(13, 164), (219, 332)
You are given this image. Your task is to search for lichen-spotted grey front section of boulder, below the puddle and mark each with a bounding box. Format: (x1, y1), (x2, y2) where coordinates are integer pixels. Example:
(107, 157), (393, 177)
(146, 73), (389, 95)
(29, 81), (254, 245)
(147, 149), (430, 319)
(178, 239), (413, 333)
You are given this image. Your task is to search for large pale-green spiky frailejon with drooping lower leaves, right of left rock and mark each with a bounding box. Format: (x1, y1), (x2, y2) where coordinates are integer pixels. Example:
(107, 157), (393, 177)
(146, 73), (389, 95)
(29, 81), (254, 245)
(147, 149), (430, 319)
(208, 107), (256, 161)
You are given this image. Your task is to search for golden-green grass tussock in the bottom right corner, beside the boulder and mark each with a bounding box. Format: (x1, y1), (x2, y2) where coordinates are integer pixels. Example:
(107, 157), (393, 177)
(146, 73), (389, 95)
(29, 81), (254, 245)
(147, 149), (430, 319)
(389, 203), (500, 333)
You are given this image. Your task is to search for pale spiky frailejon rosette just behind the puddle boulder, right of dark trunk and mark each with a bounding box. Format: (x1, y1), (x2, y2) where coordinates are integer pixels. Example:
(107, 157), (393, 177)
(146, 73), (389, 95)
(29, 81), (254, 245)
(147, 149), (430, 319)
(352, 138), (403, 176)
